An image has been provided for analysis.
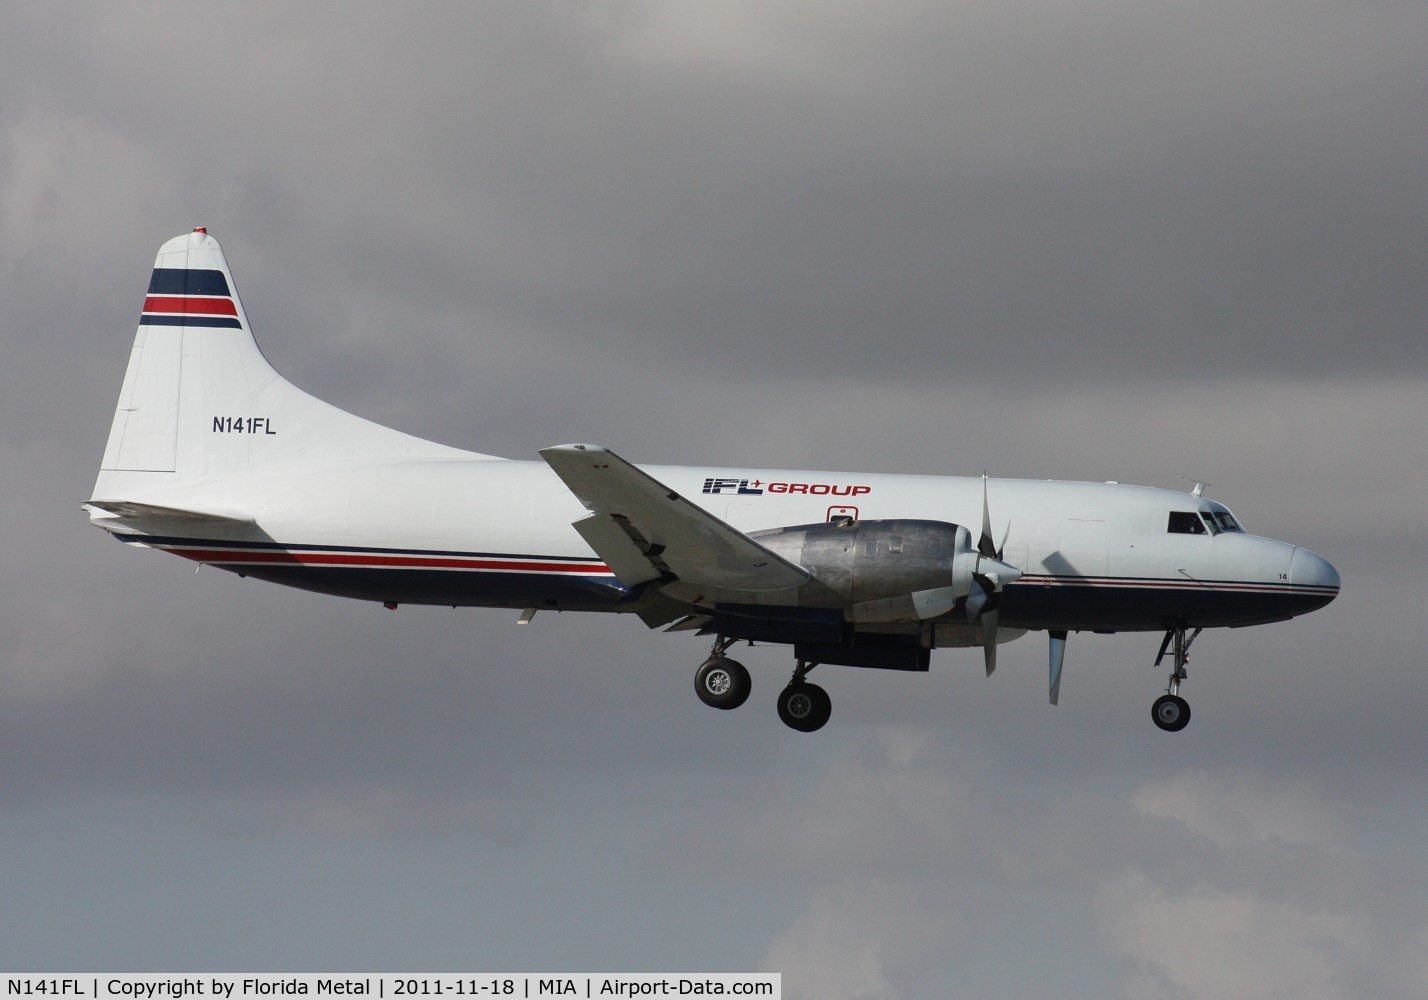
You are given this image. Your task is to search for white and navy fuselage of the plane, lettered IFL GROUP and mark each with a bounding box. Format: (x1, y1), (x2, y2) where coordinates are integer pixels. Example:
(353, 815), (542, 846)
(105, 456), (1338, 631)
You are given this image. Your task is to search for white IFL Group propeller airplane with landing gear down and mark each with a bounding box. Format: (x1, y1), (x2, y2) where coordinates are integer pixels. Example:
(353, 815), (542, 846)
(83, 234), (1339, 731)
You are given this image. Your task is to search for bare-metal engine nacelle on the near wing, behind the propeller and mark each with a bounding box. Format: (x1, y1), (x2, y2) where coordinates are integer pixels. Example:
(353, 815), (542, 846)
(751, 520), (977, 605)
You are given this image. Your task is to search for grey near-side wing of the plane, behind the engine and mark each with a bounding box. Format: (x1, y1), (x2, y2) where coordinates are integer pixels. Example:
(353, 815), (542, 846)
(540, 444), (810, 593)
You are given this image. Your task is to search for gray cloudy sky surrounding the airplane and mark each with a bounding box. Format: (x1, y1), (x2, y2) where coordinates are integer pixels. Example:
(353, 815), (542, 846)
(0, 0), (1428, 1000)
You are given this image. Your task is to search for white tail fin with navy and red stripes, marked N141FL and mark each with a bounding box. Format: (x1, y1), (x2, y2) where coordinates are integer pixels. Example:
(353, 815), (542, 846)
(94, 229), (491, 499)
